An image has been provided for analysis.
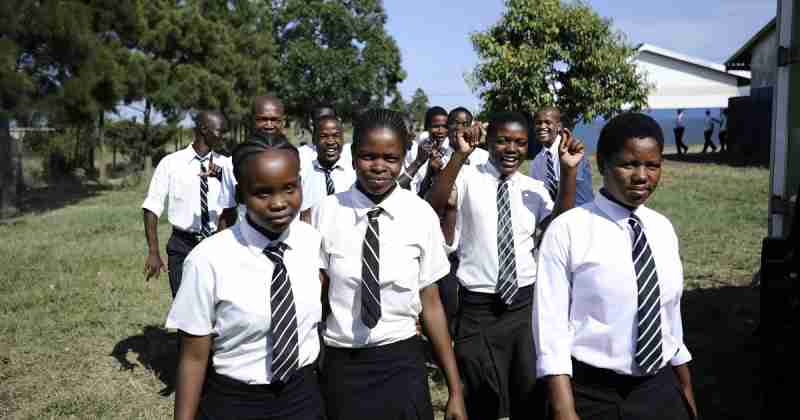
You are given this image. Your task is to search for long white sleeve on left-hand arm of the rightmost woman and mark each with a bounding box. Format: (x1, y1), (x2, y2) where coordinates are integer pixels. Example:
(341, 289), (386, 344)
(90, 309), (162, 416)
(532, 222), (573, 378)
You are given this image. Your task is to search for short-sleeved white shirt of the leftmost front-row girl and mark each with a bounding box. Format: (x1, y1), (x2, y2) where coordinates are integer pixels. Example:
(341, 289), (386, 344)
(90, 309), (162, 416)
(166, 220), (322, 384)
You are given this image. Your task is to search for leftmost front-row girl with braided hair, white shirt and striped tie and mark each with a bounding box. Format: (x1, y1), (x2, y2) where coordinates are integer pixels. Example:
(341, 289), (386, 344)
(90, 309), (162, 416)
(166, 133), (324, 420)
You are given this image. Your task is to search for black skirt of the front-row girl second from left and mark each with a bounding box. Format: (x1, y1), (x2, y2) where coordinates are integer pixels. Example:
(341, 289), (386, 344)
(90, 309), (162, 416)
(321, 336), (433, 420)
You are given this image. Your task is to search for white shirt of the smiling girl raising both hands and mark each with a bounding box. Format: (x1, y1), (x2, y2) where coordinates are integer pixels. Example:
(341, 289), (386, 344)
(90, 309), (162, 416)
(453, 162), (553, 293)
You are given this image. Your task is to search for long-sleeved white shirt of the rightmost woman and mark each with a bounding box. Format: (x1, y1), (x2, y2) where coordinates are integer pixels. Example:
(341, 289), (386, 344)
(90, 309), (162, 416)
(533, 194), (692, 377)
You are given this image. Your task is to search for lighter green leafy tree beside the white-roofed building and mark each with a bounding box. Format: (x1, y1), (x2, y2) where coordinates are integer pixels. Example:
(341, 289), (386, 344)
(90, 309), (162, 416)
(472, 0), (649, 127)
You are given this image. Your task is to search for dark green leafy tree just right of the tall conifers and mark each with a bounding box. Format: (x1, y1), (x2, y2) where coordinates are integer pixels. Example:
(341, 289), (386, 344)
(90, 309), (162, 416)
(272, 0), (406, 121)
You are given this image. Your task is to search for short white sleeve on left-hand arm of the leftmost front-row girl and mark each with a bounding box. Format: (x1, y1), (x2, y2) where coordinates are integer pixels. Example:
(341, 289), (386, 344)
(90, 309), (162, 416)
(166, 254), (216, 336)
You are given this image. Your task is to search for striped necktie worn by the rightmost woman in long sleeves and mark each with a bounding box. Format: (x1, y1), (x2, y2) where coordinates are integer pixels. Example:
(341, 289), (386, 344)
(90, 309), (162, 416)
(628, 213), (662, 375)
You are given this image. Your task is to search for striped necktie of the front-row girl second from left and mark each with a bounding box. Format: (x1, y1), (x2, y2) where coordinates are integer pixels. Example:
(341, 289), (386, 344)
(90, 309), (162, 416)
(361, 207), (383, 329)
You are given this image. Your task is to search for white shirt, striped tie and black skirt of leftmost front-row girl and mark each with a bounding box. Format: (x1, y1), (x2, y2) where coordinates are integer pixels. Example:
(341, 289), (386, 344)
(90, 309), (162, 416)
(166, 220), (324, 420)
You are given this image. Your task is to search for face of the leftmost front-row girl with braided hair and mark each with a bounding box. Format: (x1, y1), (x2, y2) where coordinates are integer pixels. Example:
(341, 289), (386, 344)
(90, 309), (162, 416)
(237, 149), (303, 233)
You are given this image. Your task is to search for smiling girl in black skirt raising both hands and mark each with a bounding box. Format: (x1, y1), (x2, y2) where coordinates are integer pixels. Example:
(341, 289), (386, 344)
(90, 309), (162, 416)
(430, 112), (584, 419)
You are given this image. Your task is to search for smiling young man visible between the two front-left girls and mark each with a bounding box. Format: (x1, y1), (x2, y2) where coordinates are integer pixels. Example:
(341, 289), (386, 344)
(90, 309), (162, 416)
(300, 116), (356, 221)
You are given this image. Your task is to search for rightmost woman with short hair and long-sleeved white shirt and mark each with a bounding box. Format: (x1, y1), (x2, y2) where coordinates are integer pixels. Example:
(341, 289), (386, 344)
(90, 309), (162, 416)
(533, 113), (697, 420)
